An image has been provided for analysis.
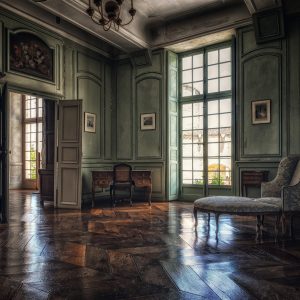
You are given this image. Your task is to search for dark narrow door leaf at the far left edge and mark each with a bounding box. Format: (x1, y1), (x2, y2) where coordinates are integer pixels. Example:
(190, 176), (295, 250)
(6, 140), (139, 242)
(0, 83), (9, 223)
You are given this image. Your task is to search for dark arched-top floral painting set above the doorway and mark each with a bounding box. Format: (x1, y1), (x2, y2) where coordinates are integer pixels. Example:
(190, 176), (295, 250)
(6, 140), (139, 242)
(8, 31), (54, 82)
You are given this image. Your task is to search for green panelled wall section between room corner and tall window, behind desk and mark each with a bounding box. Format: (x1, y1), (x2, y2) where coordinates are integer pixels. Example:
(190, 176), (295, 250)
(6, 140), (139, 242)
(113, 50), (166, 200)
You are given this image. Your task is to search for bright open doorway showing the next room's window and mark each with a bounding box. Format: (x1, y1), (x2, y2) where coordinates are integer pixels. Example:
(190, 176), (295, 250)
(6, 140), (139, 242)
(8, 92), (44, 191)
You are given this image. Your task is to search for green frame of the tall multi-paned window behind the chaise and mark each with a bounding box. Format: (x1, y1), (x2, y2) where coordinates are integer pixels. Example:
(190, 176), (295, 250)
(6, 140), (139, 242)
(178, 39), (235, 190)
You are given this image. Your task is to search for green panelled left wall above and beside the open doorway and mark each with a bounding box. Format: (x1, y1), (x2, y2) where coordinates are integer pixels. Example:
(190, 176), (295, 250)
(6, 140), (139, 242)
(0, 11), (114, 204)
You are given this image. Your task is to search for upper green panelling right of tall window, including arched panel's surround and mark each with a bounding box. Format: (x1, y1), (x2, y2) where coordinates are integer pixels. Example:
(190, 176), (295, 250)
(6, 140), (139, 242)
(236, 27), (286, 160)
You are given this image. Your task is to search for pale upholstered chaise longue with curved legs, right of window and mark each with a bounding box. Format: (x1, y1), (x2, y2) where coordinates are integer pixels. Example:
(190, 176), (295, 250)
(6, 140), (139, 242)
(194, 156), (300, 239)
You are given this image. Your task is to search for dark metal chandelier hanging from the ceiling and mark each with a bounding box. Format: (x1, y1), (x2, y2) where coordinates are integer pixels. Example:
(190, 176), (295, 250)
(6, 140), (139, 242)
(86, 0), (136, 31)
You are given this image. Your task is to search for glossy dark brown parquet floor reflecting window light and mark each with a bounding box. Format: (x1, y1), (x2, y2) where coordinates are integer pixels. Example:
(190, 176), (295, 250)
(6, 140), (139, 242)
(0, 191), (300, 300)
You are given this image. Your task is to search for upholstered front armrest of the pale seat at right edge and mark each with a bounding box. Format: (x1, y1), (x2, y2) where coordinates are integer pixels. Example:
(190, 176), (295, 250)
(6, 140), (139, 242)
(281, 182), (300, 212)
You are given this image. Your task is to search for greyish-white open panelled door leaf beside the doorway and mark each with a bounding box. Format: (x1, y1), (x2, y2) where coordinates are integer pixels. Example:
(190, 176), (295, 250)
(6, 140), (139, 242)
(54, 100), (82, 209)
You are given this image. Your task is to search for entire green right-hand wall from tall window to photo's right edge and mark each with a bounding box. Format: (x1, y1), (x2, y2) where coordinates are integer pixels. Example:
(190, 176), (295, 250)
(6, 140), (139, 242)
(235, 17), (300, 196)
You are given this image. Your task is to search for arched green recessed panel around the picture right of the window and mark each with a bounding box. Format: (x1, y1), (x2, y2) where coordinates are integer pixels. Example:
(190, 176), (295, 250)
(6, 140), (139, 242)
(241, 54), (282, 157)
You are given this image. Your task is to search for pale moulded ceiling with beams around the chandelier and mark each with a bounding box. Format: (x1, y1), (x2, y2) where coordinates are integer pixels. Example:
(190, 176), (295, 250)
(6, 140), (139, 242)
(0, 0), (281, 53)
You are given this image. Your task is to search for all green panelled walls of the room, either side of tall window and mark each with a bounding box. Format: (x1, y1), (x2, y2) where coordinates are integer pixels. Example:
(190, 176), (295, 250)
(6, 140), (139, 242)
(0, 7), (300, 204)
